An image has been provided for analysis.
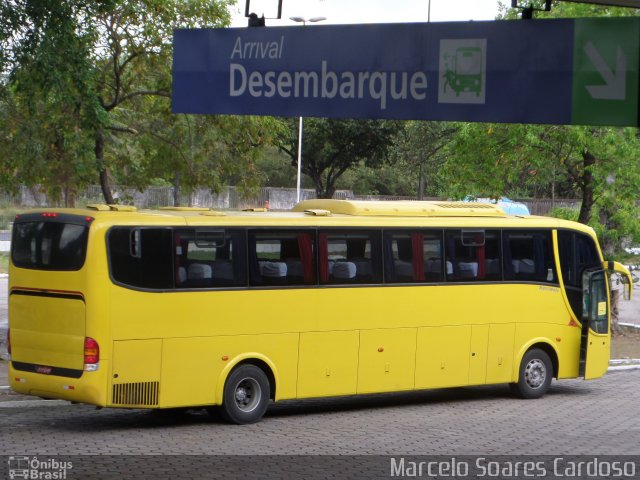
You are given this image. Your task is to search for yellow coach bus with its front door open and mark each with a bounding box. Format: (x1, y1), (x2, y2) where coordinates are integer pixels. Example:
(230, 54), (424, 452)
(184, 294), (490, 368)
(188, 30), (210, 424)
(9, 200), (630, 424)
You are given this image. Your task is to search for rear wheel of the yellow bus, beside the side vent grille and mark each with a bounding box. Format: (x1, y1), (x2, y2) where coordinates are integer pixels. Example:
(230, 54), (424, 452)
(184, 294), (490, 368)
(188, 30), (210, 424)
(220, 365), (270, 425)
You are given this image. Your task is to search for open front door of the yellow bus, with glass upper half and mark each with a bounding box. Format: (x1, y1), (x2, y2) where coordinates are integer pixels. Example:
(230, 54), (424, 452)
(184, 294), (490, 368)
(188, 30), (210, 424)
(580, 267), (611, 380)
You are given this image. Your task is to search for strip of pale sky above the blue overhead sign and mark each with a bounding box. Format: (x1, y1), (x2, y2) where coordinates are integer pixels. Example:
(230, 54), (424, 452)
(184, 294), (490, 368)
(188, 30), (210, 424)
(231, 0), (504, 27)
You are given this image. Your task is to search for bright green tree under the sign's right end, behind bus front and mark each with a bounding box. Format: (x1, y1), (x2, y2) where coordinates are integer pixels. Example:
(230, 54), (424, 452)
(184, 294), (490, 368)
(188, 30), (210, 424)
(444, 124), (640, 224)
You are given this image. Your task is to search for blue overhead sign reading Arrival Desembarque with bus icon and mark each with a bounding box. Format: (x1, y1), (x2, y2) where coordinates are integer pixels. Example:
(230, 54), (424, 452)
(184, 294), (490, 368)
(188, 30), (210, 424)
(173, 19), (640, 125)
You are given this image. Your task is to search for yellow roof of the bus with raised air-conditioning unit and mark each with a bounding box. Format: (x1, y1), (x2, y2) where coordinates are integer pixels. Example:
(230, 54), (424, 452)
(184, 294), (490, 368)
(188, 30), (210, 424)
(15, 199), (595, 236)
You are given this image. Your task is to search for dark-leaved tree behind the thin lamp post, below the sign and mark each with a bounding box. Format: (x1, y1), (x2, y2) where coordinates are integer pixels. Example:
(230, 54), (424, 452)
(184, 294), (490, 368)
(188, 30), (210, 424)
(278, 118), (400, 198)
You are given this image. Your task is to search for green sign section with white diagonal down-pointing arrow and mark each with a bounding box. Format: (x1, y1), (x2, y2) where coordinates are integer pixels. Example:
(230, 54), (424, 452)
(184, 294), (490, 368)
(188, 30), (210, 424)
(571, 17), (640, 126)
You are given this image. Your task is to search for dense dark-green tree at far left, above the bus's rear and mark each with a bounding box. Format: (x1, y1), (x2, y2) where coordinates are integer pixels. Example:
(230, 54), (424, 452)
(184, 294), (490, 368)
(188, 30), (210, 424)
(0, 0), (112, 204)
